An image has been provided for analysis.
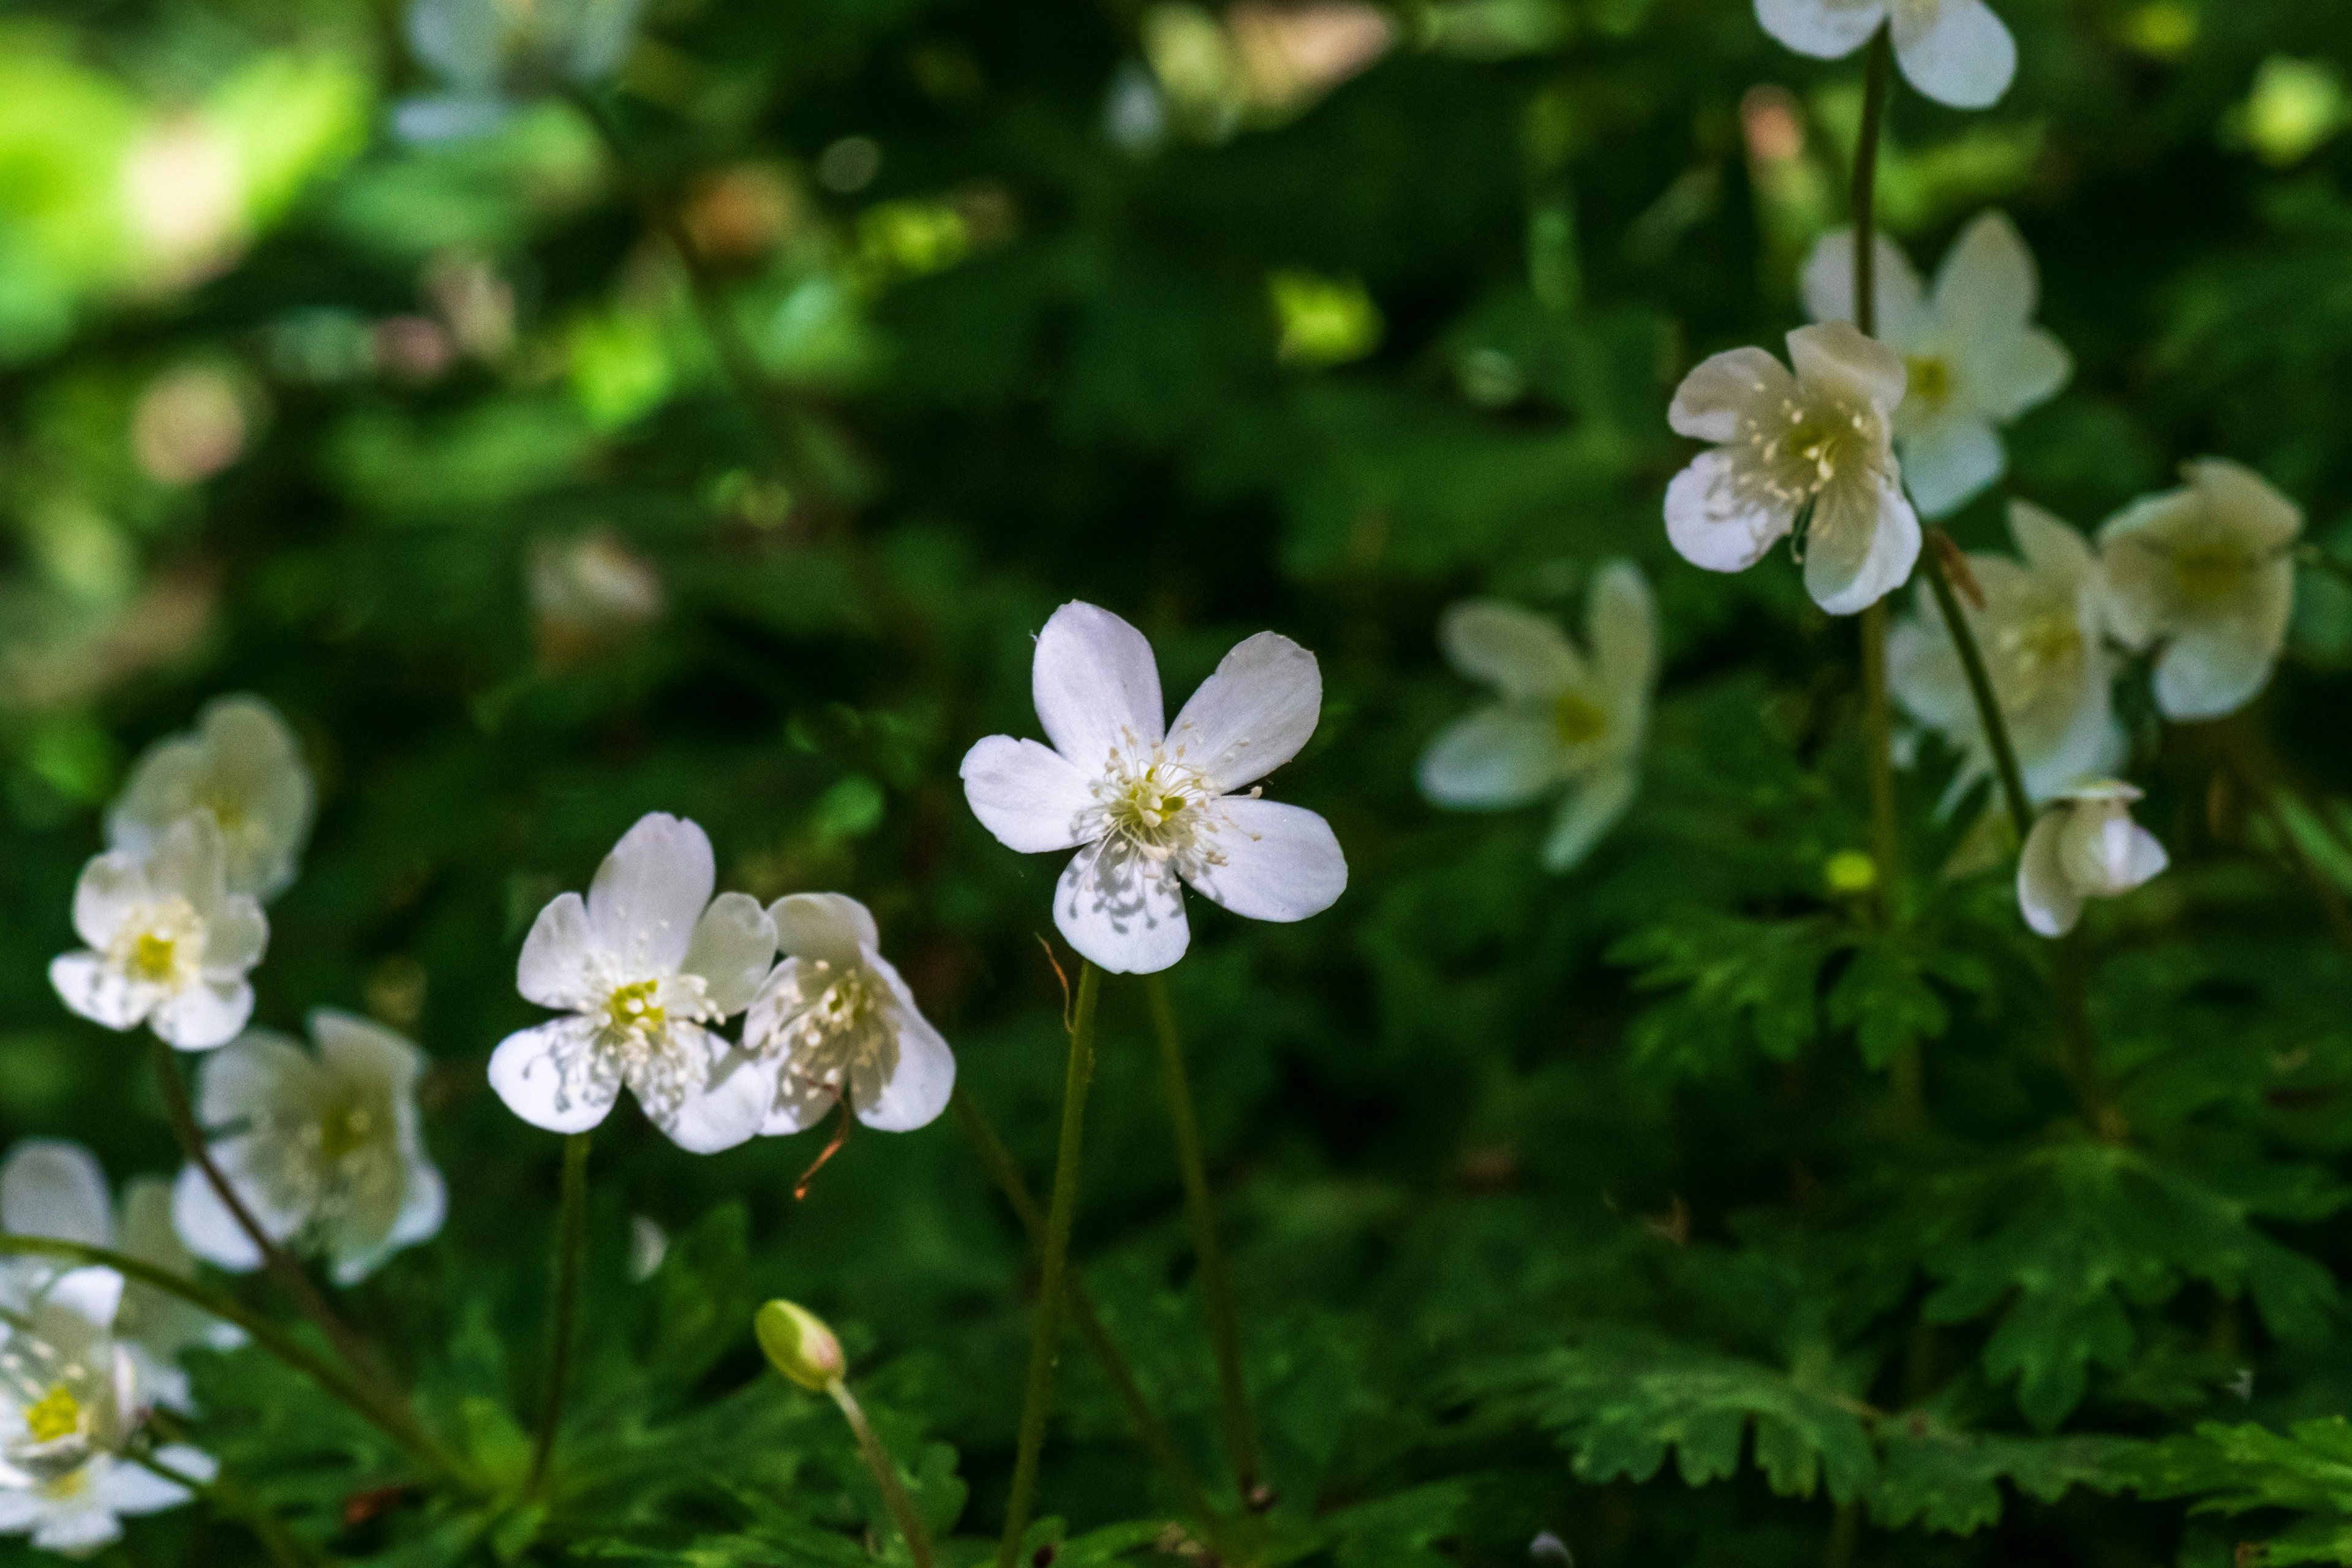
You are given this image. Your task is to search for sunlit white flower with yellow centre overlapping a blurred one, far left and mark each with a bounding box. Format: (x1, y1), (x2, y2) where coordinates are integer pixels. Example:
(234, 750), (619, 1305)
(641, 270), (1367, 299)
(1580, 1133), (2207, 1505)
(50, 811), (271, 1051)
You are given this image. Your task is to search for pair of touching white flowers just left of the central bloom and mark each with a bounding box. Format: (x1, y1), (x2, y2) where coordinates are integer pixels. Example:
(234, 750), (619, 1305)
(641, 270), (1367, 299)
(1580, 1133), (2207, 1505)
(489, 811), (955, 1154)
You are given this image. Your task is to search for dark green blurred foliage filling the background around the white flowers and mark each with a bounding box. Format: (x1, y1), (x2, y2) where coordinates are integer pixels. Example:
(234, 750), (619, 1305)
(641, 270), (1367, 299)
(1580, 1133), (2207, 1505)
(0, 0), (2352, 1568)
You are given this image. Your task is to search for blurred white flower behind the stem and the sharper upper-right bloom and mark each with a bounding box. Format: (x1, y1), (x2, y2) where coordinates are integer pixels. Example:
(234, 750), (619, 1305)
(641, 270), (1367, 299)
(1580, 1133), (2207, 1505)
(1804, 211), (2075, 517)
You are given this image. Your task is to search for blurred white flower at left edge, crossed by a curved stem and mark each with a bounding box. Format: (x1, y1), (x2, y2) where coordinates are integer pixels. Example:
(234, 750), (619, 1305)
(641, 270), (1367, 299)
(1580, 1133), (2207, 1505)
(0, 1138), (244, 1411)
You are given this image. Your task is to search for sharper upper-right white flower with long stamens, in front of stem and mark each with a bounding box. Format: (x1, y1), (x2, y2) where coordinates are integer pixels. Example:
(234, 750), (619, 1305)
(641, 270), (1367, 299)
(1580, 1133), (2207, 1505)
(1665, 322), (1919, 616)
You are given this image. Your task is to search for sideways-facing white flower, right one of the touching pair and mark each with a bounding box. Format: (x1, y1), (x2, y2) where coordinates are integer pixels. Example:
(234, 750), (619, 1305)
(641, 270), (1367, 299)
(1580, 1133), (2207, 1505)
(743, 893), (955, 1133)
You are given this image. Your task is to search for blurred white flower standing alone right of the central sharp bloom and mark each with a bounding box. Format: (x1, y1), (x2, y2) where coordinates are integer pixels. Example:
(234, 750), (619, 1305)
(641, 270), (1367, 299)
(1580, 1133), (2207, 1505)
(1420, 562), (1658, 872)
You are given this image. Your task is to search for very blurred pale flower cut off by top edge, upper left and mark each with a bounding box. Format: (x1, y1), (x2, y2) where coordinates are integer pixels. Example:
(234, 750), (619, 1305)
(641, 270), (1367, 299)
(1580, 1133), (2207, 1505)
(393, 0), (642, 141)
